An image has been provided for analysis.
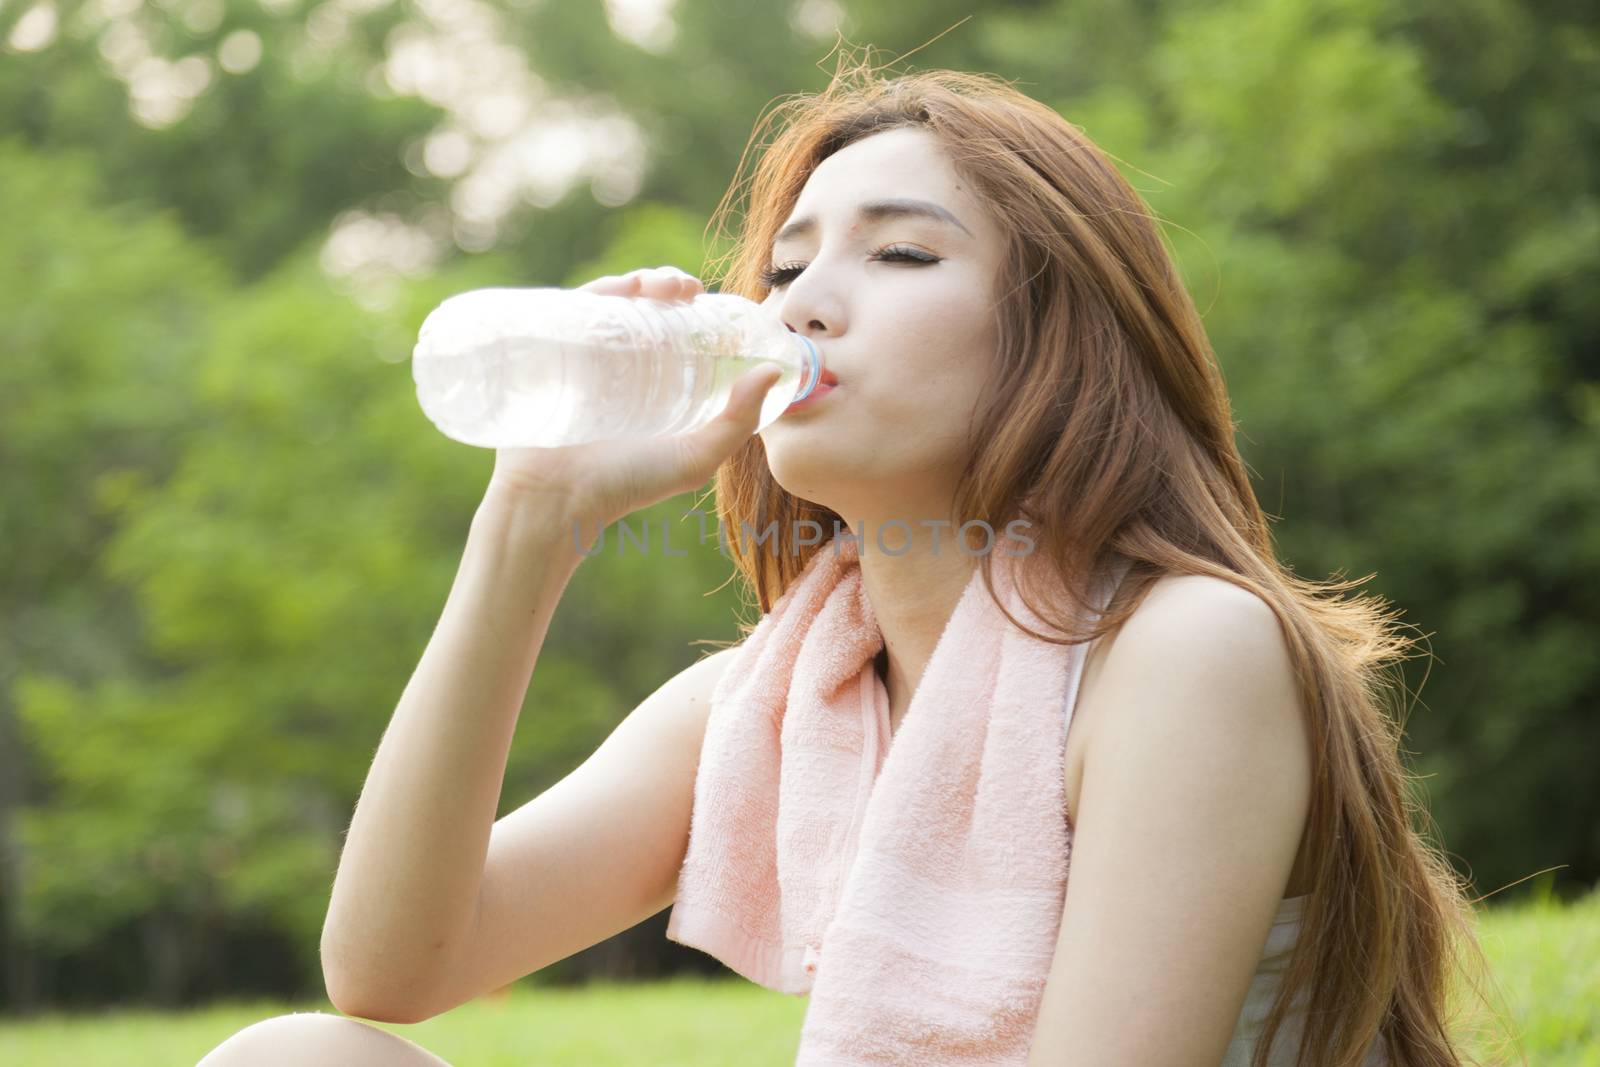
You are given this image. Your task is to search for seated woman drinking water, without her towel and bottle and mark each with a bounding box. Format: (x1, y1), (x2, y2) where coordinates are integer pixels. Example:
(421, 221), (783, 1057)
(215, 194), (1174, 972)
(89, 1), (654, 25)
(202, 62), (1497, 1067)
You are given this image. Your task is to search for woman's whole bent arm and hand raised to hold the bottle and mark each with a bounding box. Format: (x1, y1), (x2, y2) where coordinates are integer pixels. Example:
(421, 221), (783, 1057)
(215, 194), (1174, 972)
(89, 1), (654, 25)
(322, 267), (779, 1022)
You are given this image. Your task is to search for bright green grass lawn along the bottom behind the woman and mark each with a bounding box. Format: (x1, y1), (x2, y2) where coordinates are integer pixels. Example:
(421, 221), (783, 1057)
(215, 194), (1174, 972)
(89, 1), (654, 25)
(0, 891), (1600, 1067)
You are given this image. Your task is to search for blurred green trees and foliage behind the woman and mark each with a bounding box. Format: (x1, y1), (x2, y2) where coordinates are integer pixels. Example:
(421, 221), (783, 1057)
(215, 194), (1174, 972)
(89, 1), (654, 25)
(0, 0), (1600, 1013)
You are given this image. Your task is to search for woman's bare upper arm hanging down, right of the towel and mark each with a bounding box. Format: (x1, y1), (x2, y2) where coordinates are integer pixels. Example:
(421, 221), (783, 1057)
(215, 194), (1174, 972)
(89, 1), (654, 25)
(1027, 574), (1312, 1067)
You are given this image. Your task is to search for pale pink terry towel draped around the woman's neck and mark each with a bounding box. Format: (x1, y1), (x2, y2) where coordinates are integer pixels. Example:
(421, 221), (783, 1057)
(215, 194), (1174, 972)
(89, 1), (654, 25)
(667, 536), (1126, 1067)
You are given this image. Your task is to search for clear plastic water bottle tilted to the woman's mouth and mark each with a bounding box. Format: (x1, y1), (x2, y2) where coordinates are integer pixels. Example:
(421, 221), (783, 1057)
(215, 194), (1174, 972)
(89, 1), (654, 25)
(411, 288), (822, 448)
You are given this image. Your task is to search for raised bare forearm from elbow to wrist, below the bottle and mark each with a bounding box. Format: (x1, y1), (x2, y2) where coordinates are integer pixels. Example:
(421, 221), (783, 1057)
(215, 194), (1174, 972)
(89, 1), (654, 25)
(322, 485), (597, 1021)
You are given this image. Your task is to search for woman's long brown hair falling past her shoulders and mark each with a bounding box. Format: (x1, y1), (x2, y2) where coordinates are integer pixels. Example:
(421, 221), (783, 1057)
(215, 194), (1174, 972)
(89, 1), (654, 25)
(707, 54), (1510, 1067)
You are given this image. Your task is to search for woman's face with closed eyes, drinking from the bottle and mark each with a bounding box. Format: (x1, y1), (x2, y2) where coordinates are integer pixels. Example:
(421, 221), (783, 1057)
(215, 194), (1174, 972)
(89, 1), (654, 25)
(760, 128), (1002, 525)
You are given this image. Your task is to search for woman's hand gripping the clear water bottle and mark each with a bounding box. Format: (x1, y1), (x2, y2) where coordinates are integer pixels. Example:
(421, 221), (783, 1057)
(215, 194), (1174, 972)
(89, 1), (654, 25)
(490, 267), (782, 530)
